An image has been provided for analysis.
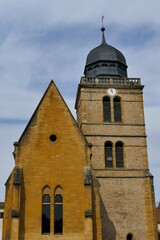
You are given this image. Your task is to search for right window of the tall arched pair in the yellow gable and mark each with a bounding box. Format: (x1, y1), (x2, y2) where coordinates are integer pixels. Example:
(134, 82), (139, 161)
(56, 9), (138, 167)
(54, 186), (63, 234)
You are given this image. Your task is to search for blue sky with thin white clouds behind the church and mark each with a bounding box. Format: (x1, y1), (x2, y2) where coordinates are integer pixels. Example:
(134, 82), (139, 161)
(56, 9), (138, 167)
(0, 0), (160, 202)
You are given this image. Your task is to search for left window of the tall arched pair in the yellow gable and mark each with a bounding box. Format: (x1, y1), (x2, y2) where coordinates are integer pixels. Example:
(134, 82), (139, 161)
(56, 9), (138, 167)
(42, 186), (51, 234)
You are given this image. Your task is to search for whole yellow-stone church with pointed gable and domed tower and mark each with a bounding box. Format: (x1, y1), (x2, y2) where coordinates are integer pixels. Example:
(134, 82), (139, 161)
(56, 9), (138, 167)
(2, 27), (157, 240)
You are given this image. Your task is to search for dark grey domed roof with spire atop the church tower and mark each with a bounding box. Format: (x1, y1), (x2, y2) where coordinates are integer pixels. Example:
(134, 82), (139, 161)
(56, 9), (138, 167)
(84, 27), (127, 77)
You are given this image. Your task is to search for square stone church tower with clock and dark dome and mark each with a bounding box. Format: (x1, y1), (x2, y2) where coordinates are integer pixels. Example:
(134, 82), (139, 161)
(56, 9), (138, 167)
(75, 26), (157, 240)
